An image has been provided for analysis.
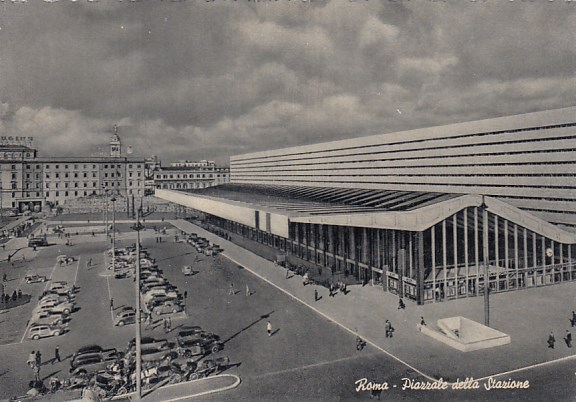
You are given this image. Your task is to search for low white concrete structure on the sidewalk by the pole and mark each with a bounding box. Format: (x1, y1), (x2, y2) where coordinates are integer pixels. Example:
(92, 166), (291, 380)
(420, 317), (510, 352)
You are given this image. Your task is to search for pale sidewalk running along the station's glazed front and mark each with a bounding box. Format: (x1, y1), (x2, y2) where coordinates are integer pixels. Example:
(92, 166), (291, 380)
(169, 220), (576, 381)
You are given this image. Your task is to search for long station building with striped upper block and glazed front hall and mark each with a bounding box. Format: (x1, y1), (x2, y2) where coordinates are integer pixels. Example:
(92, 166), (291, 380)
(156, 107), (576, 304)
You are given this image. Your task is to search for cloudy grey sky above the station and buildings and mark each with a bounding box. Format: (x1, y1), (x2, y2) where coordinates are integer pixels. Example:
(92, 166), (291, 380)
(0, 0), (576, 164)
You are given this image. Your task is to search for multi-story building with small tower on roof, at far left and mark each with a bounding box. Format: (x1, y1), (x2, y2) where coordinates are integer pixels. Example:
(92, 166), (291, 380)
(0, 129), (145, 211)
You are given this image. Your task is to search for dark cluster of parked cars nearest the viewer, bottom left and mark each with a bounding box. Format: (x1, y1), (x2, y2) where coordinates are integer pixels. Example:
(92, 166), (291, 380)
(67, 326), (230, 397)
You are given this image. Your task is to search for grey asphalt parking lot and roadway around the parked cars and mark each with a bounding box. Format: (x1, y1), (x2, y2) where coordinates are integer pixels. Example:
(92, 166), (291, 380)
(0, 223), (574, 401)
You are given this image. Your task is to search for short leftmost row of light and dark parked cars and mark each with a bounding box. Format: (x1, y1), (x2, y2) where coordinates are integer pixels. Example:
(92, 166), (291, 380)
(28, 281), (77, 340)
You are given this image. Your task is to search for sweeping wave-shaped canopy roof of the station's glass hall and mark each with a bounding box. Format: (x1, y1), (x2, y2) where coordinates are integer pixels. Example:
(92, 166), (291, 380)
(174, 183), (576, 243)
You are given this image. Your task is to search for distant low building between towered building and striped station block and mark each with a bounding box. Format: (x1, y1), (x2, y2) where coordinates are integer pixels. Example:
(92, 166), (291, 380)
(154, 160), (230, 190)
